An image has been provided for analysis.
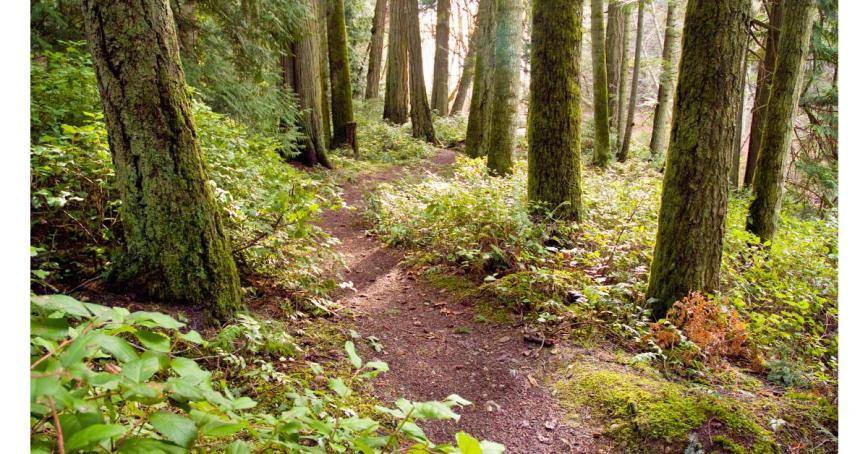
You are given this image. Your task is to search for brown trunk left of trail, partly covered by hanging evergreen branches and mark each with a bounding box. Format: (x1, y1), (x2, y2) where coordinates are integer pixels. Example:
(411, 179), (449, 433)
(288, 0), (331, 168)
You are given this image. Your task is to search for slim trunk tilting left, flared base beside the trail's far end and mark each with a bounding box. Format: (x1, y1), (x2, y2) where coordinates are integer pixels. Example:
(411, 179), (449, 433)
(403, 0), (440, 145)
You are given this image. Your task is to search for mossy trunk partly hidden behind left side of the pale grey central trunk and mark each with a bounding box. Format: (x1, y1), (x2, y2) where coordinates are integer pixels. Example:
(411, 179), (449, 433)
(464, 0), (497, 158)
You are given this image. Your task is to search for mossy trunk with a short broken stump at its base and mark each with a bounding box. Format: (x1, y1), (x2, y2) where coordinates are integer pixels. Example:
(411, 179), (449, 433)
(328, 0), (354, 148)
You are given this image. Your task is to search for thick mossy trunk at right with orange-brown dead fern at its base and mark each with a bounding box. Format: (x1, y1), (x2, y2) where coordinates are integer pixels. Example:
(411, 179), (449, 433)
(647, 0), (751, 318)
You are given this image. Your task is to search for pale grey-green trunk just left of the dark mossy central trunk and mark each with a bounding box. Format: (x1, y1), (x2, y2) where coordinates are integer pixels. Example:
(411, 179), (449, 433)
(487, 0), (523, 175)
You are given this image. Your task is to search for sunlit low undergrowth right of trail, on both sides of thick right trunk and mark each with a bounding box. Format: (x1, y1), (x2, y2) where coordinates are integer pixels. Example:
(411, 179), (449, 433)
(368, 158), (838, 382)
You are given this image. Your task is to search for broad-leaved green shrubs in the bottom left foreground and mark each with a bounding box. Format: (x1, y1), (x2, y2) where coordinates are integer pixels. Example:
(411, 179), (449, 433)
(30, 295), (504, 453)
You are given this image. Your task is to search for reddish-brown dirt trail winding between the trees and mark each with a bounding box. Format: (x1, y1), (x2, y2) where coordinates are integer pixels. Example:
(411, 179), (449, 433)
(321, 150), (595, 453)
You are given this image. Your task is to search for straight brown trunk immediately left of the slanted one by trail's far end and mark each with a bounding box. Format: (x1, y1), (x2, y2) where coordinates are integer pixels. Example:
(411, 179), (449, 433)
(383, 0), (410, 125)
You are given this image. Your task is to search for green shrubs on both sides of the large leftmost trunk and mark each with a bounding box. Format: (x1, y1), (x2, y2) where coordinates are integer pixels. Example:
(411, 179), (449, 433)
(30, 46), (339, 296)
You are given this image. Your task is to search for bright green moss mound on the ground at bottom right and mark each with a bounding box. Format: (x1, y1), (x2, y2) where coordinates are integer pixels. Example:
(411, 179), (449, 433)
(555, 363), (776, 452)
